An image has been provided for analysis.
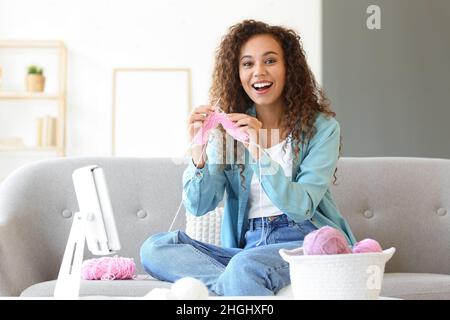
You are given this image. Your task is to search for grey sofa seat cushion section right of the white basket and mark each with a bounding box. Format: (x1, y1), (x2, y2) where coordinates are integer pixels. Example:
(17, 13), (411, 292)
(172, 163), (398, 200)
(380, 273), (450, 300)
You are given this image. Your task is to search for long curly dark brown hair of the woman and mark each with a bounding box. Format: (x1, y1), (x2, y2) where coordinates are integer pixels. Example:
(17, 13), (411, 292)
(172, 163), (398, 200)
(209, 20), (342, 188)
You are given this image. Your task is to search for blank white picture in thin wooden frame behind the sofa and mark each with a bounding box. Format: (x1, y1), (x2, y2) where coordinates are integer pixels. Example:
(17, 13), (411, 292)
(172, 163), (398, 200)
(112, 68), (191, 157)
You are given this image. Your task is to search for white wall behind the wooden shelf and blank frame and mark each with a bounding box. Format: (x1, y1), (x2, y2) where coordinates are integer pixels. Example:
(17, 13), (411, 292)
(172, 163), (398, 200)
(0, 0), (321, 162)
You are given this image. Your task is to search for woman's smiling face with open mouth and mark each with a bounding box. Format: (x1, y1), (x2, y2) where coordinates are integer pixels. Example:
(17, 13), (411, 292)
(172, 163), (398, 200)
(239, 34), (286, 106)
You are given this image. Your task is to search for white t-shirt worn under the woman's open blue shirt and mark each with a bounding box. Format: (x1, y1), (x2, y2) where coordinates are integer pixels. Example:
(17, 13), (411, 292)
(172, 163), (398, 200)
(248, 140), (293, 219)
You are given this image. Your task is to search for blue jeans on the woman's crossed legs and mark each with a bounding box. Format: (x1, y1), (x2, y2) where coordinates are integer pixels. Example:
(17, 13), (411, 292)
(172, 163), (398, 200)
(140, 214), (316, 296)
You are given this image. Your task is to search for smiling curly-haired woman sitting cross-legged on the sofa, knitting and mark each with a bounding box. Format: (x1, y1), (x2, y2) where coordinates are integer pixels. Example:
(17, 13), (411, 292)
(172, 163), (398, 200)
(140, 20), (356, 296)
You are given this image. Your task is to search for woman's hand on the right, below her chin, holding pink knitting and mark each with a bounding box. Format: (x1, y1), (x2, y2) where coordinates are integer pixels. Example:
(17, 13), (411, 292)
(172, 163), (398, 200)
(228, 113), (262, 159)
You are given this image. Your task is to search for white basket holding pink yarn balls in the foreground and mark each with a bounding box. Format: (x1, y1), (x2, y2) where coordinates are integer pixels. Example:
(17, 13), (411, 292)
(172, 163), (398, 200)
(279, 248), (395, 300)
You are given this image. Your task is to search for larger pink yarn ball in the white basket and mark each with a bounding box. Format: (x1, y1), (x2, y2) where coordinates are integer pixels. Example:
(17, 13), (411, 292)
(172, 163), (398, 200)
(303, 226), (352, 255)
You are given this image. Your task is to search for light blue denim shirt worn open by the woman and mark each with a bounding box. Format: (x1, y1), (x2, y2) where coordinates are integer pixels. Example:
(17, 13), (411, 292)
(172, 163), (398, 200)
(183, 106), (356, 248)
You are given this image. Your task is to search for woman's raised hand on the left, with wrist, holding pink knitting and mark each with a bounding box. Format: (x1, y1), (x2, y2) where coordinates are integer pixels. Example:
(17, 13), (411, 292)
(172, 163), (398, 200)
(187, 105), (215, 168)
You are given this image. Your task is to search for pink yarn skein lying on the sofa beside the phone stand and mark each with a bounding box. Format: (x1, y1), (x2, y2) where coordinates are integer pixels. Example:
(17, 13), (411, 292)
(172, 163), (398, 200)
(81, 256), (136, 280)
